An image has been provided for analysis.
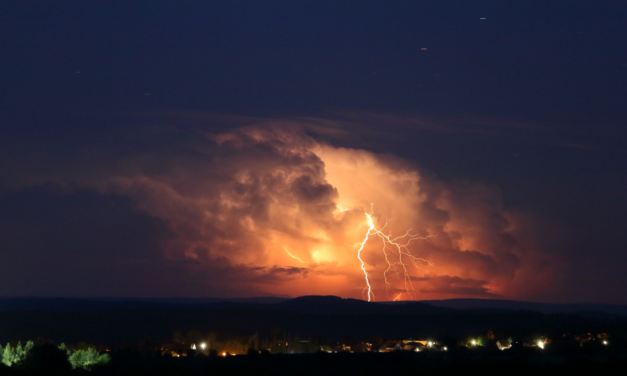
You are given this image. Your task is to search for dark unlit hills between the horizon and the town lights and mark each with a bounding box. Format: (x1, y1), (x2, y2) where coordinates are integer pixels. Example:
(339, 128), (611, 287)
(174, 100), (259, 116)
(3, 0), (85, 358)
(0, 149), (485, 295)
(0, 296), (627, 343)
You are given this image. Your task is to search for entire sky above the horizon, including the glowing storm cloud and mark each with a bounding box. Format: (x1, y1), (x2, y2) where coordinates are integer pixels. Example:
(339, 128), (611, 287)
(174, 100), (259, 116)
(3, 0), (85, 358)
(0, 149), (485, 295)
(0, 0), (627, 304)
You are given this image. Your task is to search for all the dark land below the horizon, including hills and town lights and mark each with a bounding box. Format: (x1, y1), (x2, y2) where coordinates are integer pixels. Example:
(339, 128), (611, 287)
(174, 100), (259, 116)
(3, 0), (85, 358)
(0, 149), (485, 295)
(0, 297), (627, 376)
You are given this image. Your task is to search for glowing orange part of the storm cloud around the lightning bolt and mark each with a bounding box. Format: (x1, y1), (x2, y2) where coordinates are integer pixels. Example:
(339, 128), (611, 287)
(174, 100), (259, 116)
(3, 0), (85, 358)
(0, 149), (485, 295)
(112, 126), (556, 300)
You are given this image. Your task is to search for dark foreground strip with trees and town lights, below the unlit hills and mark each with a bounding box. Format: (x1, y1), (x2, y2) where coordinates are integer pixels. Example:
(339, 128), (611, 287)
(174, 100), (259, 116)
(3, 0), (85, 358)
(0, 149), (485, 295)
(0, 329), (627, 376)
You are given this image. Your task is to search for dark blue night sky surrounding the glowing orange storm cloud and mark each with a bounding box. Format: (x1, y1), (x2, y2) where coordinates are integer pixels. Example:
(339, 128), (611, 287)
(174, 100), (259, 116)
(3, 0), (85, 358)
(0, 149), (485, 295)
(0, 0), (627, 304)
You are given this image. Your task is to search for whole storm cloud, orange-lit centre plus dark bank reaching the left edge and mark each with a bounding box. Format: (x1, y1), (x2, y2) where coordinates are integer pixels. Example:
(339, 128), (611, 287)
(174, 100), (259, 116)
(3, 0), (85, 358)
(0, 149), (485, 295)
(2, 122), (548, 300)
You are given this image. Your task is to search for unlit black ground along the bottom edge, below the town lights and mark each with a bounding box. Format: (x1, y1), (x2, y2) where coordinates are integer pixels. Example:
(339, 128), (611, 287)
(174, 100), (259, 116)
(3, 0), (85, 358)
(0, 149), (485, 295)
(0, 350), (627, 376)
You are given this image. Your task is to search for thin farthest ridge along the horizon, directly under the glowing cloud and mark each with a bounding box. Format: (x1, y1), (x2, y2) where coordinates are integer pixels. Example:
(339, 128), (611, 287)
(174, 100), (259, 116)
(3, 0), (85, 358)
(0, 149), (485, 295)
(0, 295), (627, 319)
